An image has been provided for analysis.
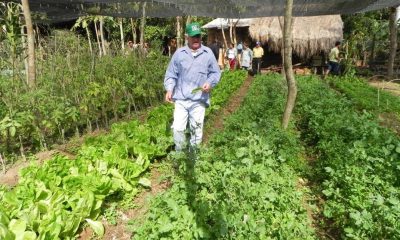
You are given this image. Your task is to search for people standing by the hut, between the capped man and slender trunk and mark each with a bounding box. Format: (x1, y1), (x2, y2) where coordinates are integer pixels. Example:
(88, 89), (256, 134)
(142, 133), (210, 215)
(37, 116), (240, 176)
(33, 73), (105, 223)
(210, 40), (264, 74)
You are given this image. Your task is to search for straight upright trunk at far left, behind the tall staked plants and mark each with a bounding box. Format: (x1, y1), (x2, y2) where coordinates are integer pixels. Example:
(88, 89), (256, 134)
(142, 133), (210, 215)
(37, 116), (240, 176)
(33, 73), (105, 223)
(22, 0), (36, 89)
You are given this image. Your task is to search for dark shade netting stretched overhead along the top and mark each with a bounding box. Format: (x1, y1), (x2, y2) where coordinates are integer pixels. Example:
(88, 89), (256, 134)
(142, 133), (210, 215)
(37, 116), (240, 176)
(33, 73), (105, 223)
(5, 0), (399, 21)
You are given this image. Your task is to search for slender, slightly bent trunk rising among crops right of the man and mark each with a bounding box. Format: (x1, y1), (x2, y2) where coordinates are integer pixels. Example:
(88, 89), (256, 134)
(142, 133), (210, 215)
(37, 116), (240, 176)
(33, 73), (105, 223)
(282, 0), (297, 129)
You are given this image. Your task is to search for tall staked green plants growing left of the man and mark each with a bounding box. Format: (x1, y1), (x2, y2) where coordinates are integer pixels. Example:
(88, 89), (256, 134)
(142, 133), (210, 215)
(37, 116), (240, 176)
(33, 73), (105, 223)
(0, 31), (168, 156)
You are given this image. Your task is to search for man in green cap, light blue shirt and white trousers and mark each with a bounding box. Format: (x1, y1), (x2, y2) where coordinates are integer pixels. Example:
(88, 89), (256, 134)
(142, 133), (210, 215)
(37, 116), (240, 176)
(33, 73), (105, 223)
(164, 23), (221, 152)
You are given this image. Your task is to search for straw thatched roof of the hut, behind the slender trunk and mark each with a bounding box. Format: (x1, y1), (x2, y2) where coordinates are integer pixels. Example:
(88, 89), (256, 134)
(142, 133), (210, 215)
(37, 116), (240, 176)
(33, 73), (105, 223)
(249, 15), (343, 57)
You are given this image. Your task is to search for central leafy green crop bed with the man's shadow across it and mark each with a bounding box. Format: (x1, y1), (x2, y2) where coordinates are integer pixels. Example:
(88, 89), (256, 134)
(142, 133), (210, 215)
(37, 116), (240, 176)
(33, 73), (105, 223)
(132, 74), (315, 239)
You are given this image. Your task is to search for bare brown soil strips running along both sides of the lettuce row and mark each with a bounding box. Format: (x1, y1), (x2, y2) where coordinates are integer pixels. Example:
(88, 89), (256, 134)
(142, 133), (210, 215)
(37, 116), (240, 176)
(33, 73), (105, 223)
(0, 76), (253, 240)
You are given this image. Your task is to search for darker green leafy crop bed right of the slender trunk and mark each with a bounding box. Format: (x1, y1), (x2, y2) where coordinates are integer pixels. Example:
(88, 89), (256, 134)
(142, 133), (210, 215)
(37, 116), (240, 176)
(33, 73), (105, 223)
(296, 77), (400, 239)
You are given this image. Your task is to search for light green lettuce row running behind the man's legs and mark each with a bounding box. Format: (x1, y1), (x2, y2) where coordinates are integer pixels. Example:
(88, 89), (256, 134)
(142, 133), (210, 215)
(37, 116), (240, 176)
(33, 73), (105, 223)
(0, 72), (246, 240)
